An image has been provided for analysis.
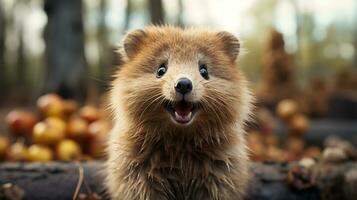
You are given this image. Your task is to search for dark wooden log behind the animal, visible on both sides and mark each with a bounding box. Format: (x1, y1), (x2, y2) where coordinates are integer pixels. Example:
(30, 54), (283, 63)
(0, 161), (357, 200)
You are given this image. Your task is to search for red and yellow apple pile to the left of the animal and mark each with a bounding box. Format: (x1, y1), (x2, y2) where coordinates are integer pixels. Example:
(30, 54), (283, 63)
(0, 94), (110, 161)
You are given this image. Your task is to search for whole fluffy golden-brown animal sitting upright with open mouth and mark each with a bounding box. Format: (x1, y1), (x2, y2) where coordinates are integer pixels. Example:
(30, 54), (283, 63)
(106, 26), (252, 200)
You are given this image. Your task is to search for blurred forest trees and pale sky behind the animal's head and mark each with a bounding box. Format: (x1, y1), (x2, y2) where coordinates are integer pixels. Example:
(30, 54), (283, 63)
(0, 0), (357, 104)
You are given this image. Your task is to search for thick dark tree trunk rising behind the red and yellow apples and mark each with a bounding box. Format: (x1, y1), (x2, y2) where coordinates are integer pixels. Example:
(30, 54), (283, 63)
(44, 0), (87, 100)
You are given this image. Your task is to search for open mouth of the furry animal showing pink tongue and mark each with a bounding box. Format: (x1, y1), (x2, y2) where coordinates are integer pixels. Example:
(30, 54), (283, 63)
(166, 100), (198, 124)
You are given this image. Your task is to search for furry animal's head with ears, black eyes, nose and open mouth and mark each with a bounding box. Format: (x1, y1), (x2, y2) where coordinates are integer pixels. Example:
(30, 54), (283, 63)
(112, 27), (245, 130)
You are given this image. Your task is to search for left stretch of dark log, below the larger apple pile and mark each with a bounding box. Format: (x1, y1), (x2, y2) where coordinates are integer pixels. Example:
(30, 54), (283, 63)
(0, 162), (105, 199)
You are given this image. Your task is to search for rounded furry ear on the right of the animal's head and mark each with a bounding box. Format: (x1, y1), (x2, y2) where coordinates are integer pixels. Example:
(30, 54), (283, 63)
(217, 31), (240, 61)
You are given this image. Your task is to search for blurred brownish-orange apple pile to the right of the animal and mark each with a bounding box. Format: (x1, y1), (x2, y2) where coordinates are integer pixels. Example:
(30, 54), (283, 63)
(248, 99), (322, 162)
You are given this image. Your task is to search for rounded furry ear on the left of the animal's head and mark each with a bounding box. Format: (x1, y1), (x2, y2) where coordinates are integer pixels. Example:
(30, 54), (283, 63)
(123, 29), (146, 58)
